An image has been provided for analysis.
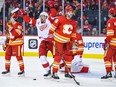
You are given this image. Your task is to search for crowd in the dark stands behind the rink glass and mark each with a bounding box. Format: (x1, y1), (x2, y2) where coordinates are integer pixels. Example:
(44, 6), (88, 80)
(0, 0), (116, 36)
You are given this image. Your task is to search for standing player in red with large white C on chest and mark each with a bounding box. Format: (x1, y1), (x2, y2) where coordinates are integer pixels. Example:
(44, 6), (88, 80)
(48, 5), (77, 79)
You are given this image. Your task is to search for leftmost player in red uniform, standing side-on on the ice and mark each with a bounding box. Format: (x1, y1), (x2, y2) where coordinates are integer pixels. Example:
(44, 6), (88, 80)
(2, 13), (24, 75)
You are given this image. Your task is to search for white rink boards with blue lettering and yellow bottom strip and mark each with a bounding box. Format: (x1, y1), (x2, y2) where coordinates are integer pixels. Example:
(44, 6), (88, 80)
(0, 36), (105, 58)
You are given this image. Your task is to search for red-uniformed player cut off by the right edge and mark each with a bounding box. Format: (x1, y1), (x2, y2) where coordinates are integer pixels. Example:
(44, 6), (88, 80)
(101, 8), (116, 79)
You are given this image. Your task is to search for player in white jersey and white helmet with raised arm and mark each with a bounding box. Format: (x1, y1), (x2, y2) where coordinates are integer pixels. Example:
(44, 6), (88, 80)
(23, 12), (53, 77)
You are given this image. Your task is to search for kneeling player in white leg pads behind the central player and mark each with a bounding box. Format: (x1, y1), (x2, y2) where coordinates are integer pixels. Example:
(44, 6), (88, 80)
(71, 33), (89, 73)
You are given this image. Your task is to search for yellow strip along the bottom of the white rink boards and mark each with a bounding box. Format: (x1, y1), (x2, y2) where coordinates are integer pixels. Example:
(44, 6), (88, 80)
(0, 52), (104, 59)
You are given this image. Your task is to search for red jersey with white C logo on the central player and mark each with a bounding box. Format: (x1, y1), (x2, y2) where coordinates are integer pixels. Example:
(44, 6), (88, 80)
(49, 16), (77, 43)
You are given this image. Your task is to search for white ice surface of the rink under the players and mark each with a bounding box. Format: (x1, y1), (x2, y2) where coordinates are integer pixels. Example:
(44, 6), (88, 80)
(0, 57), (116, 87)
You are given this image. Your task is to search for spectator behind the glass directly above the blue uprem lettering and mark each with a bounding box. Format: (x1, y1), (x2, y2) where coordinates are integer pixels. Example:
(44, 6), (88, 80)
(83, 20), (91, 36)
